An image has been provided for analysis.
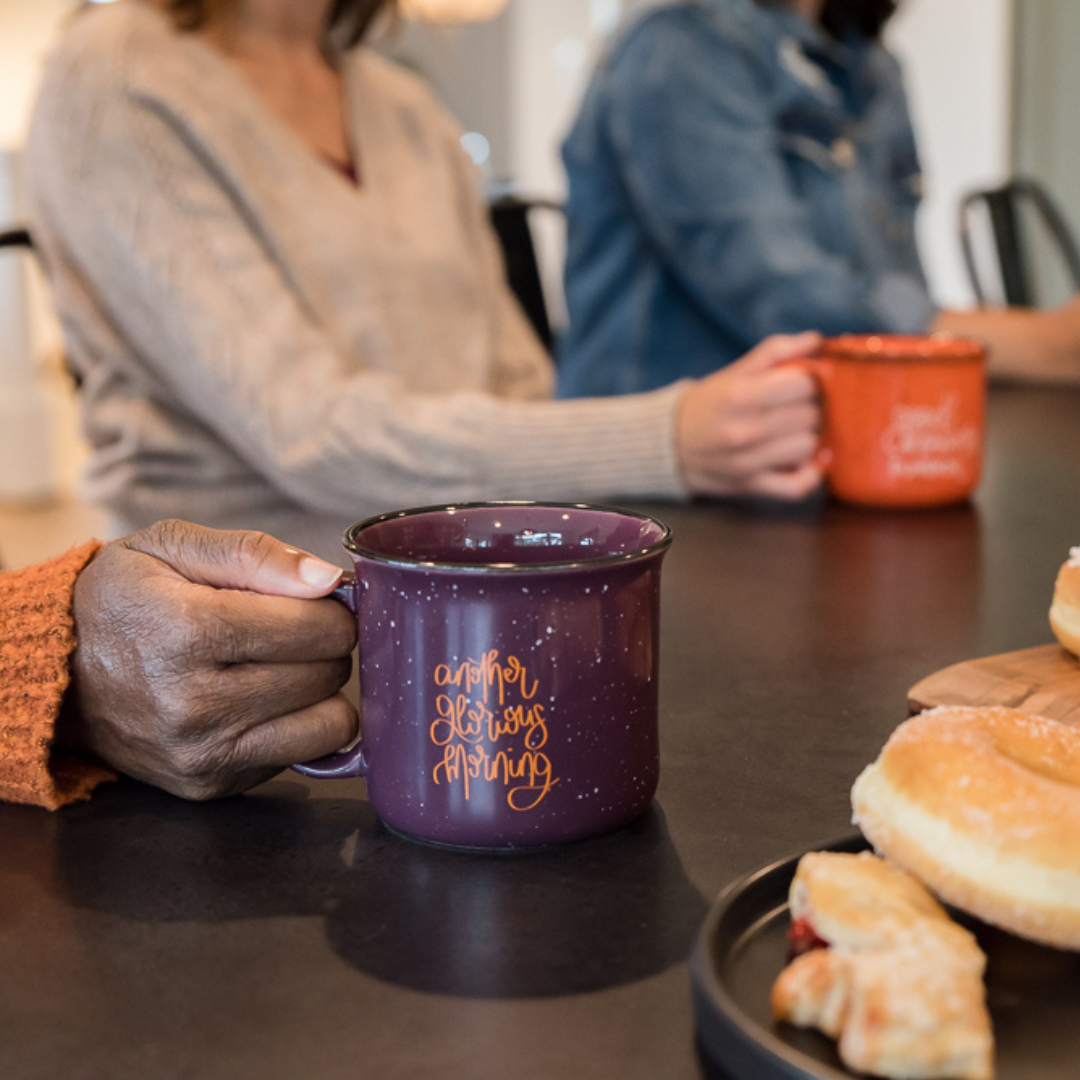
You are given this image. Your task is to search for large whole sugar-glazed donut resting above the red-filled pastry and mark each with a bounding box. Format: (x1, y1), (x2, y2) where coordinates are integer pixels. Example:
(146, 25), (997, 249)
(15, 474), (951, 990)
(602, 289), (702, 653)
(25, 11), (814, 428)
(851, 706), (1080, 949)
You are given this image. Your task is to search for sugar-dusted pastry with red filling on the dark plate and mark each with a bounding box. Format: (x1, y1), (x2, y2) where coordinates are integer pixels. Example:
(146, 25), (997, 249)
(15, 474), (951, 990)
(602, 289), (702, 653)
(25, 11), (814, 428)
(771, 852), (994, 1080)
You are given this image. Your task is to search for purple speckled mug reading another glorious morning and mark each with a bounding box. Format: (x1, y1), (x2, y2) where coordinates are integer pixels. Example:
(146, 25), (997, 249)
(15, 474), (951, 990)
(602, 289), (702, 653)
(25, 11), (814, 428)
(295, 502), (671, 850)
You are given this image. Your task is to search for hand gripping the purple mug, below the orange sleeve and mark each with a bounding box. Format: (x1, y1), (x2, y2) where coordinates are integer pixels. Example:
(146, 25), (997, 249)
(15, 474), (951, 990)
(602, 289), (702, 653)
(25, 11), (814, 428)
(56, 522), (357, 799)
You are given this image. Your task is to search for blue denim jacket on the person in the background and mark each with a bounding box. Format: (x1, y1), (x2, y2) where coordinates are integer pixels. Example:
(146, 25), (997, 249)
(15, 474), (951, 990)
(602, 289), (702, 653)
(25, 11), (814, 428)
(559, 0), (935, 396)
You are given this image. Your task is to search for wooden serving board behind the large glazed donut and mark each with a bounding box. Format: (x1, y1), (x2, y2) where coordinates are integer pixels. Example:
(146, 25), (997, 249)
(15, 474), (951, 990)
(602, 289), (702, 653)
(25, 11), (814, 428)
(907, 645), (1080, 727)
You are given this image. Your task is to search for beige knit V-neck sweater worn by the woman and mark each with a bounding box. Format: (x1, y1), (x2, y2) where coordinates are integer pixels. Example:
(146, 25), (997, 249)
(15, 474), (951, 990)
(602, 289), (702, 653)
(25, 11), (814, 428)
(28, 0), (683, 559)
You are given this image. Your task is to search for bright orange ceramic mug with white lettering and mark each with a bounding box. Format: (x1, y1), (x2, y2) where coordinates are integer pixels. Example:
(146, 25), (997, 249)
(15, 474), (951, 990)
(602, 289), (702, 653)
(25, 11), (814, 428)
(810, 334), (986, 507)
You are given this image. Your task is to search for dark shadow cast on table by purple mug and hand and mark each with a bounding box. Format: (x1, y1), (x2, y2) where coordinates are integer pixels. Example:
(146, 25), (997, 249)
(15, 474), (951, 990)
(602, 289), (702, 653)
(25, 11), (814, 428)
(56, 781), (706, 998)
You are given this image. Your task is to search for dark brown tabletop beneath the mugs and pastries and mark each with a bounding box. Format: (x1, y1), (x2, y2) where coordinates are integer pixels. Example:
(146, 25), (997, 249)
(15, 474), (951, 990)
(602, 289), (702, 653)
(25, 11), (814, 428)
(0, 389), (1080, 1080)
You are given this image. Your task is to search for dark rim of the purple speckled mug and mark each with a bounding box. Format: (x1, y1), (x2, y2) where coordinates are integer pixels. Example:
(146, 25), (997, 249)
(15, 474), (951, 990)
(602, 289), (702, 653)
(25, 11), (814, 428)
(341, 499), (672, 573)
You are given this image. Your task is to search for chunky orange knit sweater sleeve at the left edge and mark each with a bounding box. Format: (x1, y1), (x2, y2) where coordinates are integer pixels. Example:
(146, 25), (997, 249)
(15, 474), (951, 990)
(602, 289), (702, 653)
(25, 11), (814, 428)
(0, 541), (116, 810)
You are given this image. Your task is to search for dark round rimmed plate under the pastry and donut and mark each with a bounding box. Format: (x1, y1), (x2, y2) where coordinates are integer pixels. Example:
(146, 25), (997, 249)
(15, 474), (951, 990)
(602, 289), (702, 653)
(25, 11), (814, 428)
(690, 836), (1080, 1080)
